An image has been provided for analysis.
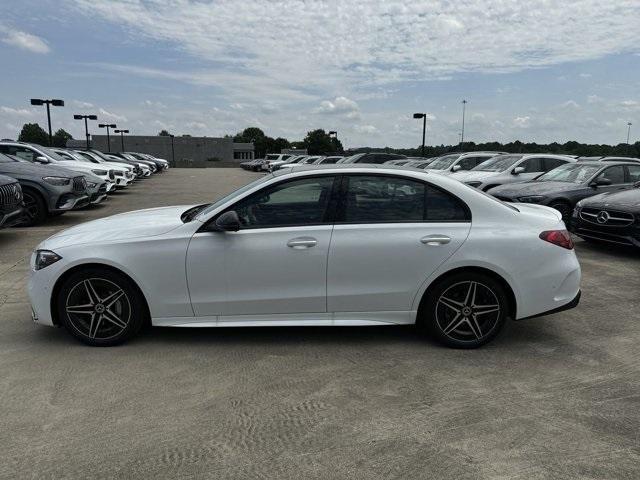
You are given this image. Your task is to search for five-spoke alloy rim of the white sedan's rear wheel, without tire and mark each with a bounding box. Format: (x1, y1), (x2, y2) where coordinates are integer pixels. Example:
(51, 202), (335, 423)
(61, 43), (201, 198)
(435, 281), (501, 342)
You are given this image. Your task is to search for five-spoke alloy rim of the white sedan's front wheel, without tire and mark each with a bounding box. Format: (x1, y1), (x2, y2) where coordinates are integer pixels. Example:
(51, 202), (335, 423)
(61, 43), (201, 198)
(65, 278), (132, 340)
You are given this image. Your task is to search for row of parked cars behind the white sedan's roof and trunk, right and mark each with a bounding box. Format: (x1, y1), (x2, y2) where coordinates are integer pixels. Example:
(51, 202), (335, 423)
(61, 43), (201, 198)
(242, 152), (640, 247)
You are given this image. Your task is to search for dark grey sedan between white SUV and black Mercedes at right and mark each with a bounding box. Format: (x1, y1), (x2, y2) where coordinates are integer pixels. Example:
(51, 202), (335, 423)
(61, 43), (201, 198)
(488, 161), (640, 223)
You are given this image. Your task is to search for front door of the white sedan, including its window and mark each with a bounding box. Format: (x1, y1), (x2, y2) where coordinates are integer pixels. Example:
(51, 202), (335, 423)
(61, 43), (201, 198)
(187, 175), (335, 320)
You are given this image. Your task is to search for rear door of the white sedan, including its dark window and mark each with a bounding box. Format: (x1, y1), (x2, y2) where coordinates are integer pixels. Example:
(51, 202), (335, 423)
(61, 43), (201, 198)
(327, 174), (471, 323)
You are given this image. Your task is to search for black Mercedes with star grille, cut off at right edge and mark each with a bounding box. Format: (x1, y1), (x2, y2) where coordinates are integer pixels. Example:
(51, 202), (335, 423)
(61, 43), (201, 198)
(570, 183), (640, 248)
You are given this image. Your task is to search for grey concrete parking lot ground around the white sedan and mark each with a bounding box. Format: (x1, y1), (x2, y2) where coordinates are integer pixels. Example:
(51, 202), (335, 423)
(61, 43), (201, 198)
(0, 169), (640, 479)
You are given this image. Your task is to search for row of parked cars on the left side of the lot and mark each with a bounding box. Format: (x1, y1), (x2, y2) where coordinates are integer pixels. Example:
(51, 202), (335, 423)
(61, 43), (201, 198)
(0, 141), (169, 228)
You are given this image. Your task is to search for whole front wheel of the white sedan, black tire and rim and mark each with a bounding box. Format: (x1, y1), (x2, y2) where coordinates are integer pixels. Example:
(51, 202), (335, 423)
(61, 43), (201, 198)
(56, 267), (148, 347)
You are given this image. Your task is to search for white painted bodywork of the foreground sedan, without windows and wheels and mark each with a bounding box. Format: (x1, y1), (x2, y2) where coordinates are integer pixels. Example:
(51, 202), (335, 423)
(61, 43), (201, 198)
(29, 166), (580, 326)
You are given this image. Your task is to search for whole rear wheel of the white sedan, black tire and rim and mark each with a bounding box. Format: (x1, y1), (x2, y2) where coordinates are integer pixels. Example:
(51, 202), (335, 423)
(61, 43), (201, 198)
(418, 272), (510, 348)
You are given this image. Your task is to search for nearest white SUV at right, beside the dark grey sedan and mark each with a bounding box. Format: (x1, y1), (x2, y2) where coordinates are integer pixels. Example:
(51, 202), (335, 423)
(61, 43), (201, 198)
(451, 153), (576, 191)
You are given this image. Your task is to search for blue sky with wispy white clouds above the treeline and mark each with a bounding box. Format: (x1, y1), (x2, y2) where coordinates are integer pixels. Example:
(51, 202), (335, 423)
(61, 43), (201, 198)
(0, 0), (640, 147)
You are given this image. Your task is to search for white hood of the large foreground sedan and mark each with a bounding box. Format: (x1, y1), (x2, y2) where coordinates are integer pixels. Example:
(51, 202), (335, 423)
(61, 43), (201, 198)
(40, 205), (195, 250)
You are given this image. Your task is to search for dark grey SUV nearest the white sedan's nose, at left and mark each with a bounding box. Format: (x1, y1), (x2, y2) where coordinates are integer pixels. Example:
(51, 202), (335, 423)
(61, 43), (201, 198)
(0, 154), (91, 226)
